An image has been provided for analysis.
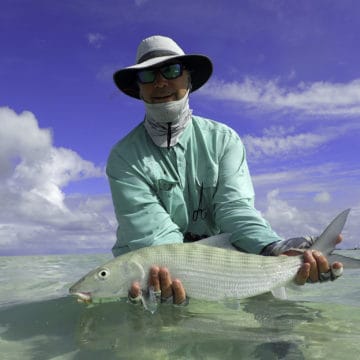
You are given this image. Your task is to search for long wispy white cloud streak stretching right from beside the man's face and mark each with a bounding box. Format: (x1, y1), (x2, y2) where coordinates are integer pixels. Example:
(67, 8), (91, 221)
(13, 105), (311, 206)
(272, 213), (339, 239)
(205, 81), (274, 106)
(200, 77), (360, 116)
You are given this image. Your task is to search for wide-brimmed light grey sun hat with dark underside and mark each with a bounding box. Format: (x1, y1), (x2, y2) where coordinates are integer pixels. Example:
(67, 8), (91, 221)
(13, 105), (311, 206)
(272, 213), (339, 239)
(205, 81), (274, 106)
(114, 35), (213, 99)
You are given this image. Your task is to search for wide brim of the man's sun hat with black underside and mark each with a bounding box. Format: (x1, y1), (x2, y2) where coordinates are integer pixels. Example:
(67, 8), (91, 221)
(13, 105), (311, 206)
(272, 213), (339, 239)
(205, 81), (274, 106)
(113, 54), (213, 99)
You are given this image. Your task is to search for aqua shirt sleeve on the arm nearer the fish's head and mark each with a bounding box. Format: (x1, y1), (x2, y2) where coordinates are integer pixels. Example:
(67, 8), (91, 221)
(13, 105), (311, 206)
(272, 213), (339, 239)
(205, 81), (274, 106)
(107, 151), (183, 256)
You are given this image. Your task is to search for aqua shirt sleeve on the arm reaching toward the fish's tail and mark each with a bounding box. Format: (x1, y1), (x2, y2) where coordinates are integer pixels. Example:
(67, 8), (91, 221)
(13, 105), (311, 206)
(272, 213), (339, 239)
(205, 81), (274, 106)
(214, 134), (281, 254)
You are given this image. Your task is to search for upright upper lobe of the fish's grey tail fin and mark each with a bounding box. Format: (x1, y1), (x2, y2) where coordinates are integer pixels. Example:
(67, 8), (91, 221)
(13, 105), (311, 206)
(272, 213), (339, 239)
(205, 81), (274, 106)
(311, 209), (350, 256)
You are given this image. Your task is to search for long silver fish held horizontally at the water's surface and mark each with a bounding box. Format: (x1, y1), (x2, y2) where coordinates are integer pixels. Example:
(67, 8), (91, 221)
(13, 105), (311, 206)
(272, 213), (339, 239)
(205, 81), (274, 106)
(70, 210), (349, 302)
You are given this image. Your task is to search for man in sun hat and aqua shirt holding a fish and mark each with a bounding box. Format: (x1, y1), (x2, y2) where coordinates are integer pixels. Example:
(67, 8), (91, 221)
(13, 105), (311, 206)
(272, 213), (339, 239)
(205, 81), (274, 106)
(107, 36), (342, 304)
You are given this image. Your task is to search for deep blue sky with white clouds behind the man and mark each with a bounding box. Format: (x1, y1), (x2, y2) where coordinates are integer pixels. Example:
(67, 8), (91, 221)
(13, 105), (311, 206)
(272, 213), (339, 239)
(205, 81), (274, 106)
(0, 0), (360, 255)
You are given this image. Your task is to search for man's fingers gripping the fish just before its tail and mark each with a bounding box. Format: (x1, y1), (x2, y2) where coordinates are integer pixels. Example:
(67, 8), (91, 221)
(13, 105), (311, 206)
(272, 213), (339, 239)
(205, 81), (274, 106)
(283, 235), (343, 285)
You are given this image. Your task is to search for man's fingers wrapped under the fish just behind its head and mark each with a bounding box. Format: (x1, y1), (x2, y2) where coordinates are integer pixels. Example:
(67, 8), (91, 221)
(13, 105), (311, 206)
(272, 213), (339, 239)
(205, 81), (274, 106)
(129, 266), (186, 305)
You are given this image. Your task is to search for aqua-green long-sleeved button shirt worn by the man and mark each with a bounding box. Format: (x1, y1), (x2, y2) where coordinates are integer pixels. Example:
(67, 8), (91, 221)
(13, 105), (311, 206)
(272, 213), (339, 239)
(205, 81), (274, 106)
(107, 116), (281, 256)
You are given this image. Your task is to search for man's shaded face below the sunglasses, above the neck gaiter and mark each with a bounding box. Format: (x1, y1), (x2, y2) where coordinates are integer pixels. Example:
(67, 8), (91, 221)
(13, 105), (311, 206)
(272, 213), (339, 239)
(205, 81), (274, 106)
(138, 65), (190, 104)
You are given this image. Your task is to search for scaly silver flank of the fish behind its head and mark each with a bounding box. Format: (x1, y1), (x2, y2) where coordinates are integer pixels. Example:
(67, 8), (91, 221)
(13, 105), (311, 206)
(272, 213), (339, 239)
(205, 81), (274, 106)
(122, 244), (301, 300)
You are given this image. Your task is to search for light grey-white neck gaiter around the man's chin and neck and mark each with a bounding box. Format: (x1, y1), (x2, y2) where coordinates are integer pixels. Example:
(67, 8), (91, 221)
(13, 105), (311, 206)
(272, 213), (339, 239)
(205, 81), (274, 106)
(144, 91), (192, 148)
